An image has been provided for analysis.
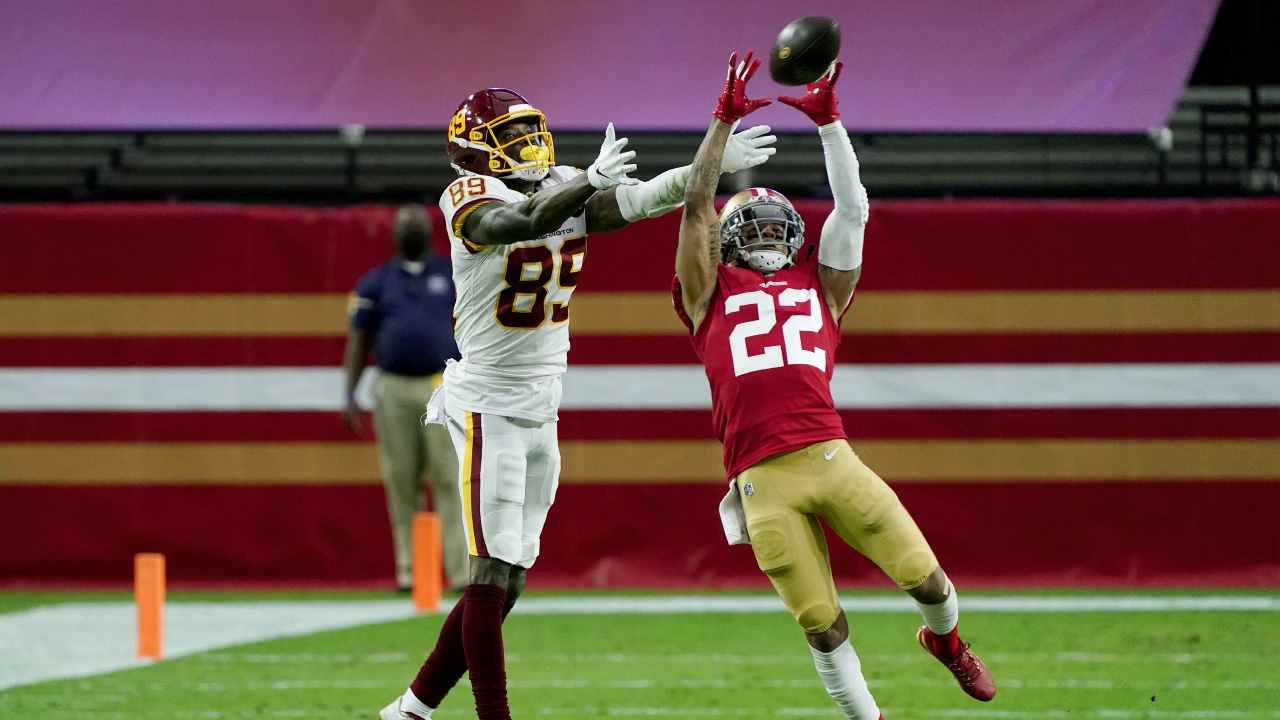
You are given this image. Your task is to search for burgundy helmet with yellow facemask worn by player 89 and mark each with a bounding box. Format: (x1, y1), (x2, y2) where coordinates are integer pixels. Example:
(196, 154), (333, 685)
(445, 87), (556, 182)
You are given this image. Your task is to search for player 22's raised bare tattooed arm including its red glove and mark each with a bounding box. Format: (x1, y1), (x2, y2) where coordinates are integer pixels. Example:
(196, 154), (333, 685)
(676, 51), (771, 331)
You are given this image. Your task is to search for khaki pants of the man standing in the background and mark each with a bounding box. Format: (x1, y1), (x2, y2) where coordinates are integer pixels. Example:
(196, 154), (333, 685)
(374, 373), (470, 588)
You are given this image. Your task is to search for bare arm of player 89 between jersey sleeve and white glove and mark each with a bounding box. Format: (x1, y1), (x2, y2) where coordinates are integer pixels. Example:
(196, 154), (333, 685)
(462, 174), (595, 245)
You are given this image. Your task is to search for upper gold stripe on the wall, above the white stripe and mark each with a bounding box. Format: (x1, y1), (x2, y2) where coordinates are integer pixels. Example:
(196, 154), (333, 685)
(0, 290), (1280, 337)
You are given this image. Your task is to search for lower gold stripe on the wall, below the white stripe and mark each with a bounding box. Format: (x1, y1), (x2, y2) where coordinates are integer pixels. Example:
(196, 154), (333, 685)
(0, 439), (1280, 484)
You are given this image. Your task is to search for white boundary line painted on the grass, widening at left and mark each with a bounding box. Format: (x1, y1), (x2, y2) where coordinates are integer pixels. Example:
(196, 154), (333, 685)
(0, 594), (1280, 689)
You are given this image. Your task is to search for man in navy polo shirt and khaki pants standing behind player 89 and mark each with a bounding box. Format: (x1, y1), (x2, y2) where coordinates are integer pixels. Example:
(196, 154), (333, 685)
(342, 205), (467, 591)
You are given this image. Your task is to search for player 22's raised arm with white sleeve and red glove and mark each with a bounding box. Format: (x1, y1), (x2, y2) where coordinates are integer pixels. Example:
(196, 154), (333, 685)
(778, 63), (868, 319)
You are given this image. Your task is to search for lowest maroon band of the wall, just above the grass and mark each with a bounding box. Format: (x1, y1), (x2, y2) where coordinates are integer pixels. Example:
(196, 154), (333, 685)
(0, 482), (1280, 588)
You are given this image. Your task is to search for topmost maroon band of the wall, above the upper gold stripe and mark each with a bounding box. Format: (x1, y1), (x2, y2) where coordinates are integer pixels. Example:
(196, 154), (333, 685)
(0, 199), (1280, 293)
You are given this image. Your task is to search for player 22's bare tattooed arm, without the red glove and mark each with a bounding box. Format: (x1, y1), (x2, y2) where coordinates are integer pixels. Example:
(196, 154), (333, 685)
(676, 119), (731, 328)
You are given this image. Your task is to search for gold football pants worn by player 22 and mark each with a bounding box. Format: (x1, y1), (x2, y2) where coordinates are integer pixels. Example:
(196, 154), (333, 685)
(736, 439), (938, 633)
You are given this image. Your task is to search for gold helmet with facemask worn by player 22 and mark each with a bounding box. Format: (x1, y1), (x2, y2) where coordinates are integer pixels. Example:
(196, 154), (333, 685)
(721, 197), (804, 273)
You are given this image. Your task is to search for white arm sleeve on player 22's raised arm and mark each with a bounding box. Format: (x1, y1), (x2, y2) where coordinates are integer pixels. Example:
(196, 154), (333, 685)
(818, 120), (869, 272)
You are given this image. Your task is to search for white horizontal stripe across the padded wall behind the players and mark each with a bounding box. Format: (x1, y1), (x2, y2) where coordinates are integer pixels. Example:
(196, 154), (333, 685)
(0, 363), (1280, 411)
